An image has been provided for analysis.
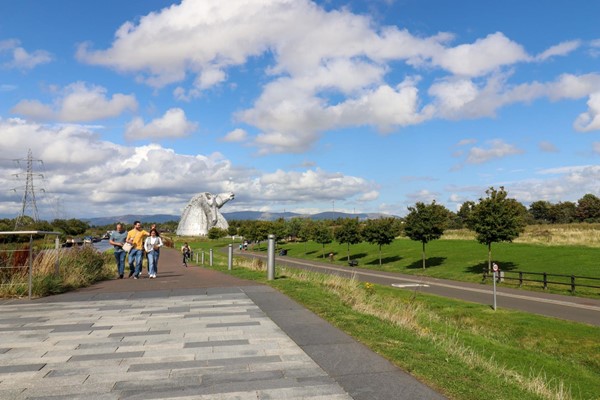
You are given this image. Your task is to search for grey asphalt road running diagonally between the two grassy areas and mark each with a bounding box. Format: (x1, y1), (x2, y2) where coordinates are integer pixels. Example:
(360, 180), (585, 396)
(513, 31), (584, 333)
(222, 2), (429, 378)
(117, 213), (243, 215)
(235, 250), (600, 326)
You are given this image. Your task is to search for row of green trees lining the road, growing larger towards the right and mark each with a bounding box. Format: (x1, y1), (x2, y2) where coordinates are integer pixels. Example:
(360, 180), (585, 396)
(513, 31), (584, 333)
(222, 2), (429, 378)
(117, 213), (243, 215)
(225, 187), (528, 270)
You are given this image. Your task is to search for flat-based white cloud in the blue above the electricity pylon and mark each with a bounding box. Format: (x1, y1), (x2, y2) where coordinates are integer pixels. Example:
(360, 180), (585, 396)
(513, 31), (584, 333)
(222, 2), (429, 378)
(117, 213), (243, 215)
(11, 82), (138, 122)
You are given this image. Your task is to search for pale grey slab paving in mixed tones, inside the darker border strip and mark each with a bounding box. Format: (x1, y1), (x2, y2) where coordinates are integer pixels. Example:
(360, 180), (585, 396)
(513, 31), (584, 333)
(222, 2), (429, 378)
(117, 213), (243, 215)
(0, 290), (351, 400)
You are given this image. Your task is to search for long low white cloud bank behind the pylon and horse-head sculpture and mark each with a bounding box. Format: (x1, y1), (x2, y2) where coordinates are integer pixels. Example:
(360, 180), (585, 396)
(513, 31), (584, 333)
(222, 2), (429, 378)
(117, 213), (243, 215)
(0, 118), (376, 218)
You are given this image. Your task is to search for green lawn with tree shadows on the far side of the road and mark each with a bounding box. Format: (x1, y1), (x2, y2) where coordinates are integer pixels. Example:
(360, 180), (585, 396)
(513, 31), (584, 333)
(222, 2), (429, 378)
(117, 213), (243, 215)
(272, 238), (600, 298)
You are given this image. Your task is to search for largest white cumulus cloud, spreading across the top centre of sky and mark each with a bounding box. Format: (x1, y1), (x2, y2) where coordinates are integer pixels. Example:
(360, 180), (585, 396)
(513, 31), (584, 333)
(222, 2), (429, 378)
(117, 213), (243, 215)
(77, 0), (558, 154)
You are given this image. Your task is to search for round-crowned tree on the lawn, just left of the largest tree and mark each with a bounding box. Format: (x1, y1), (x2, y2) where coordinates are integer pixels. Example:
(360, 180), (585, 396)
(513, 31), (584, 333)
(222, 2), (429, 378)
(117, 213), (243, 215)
(404, 200), (450, 269)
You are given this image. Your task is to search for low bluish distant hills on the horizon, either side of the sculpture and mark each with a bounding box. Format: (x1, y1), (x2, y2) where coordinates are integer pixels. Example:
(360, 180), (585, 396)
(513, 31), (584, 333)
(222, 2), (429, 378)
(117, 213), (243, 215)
(82, 211), (396, 226)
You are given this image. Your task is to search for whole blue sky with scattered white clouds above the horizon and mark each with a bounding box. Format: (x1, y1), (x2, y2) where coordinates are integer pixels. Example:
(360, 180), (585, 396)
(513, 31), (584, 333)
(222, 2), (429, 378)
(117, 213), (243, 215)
(0, 0), (600, 219)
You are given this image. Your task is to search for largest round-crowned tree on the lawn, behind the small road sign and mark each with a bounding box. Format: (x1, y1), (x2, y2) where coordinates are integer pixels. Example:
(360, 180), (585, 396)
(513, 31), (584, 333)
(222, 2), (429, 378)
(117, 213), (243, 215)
(469, 186), (527, 273)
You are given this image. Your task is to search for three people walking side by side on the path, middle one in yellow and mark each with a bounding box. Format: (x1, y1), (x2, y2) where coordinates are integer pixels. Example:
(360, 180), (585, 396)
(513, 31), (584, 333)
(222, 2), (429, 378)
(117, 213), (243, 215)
(109, 221), (164, 279)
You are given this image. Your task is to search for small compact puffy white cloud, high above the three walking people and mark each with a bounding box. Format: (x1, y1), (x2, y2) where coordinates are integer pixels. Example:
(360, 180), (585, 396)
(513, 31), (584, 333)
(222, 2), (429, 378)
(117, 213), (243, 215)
(125, 108), (198, 140)
